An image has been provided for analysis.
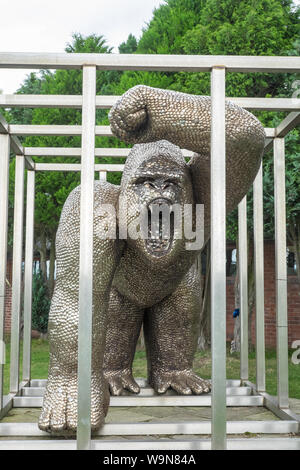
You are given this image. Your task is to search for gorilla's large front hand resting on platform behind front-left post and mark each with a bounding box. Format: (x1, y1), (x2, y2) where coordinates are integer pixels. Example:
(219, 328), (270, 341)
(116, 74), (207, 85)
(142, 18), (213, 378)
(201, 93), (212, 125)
(38, 374), (109, 434)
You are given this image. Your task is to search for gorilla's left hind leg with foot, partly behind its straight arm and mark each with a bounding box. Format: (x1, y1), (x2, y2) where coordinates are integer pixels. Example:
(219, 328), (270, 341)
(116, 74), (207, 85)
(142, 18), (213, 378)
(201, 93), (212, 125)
(103, 287), (144, 395)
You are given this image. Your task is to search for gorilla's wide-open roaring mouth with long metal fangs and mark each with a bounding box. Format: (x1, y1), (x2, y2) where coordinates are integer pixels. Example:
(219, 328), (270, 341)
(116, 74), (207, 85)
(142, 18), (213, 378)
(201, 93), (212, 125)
(145, 198), (174, 257)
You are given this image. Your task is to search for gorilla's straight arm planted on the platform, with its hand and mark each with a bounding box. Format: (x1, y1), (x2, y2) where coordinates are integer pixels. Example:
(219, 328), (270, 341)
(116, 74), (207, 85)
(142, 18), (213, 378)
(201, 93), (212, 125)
(39, 181), (121, 432)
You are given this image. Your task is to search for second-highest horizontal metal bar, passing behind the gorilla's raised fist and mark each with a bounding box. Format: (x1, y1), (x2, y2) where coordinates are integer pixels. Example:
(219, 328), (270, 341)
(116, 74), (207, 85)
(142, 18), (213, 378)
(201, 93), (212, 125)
(0, 94), (300, 111)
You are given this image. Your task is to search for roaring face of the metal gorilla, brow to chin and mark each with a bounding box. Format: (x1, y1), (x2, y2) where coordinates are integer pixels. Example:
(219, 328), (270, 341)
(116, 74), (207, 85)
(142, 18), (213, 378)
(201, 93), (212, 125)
(121, 151), (193, 262)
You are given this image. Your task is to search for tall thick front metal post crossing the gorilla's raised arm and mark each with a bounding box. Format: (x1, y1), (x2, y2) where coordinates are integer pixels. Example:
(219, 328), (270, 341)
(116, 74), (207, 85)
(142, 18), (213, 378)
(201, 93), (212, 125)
(210, 67), (226, 449)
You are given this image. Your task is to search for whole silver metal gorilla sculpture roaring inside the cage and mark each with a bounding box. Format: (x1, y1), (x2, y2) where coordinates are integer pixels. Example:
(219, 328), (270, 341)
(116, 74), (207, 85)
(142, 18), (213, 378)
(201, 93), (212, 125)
(39, 82), (265, 431)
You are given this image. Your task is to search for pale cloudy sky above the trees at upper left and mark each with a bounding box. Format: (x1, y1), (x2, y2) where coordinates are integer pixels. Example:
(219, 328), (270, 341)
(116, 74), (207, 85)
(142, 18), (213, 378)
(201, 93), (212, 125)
(0, 0), (164, 93)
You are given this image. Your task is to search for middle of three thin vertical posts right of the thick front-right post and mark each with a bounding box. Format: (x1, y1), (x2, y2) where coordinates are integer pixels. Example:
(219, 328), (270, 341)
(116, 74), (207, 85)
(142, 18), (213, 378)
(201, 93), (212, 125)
(253, 164), (266, 392)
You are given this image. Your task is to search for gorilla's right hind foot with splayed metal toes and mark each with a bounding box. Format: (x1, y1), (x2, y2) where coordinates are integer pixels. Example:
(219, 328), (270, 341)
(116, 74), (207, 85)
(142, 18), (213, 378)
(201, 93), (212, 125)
(151, 369), (211, 395)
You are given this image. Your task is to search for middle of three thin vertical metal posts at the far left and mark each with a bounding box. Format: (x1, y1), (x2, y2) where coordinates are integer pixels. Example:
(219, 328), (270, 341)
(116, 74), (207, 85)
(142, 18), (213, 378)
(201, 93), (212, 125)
(10, 155), (25, 393)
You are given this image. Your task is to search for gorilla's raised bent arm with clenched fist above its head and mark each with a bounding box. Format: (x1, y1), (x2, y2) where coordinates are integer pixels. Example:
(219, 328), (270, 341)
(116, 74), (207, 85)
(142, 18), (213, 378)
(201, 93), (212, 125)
(109, 85), (265, 234)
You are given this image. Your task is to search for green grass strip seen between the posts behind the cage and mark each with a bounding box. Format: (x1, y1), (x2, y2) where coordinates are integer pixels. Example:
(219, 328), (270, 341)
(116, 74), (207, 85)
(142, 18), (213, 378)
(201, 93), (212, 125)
(4, 339), (300, 399)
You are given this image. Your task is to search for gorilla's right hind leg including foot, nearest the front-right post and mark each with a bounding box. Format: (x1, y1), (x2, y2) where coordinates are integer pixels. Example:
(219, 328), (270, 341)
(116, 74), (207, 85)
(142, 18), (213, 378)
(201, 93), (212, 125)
(144, 266), (210, 395)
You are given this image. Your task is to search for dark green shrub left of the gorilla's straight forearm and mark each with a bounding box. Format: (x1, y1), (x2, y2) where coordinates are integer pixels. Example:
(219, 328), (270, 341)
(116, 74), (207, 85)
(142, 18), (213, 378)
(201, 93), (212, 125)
(32, 273), (50, 333)
